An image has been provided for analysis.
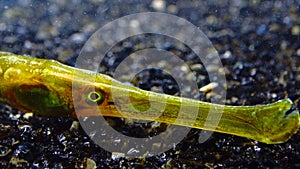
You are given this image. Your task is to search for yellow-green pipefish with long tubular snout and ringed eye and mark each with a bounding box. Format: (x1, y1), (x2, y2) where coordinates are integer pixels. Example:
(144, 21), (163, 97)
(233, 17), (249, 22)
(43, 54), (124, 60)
(0, 52), (299, 144)
